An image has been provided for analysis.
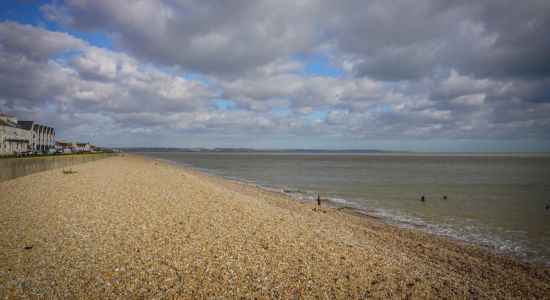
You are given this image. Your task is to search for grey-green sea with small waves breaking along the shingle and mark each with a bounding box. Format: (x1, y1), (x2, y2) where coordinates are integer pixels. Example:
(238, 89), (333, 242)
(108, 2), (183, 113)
(142, 152), (550, 266)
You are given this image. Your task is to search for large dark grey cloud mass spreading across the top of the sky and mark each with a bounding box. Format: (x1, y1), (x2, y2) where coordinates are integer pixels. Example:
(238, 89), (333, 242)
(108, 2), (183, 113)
(43, 0), (550, 80)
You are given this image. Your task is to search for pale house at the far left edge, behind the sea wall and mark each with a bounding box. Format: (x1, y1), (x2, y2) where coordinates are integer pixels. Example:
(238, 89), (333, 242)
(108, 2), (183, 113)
(0, 113), (30, 155)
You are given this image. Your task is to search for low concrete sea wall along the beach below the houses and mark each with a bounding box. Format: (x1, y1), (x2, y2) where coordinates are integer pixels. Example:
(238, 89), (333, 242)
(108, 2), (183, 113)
(0, 153), (117, 181)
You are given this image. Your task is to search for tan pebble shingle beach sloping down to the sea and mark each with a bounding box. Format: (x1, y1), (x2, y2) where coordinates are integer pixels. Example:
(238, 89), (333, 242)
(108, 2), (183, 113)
(0, 155), (550, 298)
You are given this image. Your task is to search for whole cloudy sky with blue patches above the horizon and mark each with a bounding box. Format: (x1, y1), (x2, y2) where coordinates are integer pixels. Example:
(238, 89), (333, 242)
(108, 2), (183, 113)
(0, 0), (550, 152)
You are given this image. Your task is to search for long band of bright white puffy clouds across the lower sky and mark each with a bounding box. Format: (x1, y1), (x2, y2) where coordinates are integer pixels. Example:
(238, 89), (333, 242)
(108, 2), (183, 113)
(0, 23), (550, 145)
